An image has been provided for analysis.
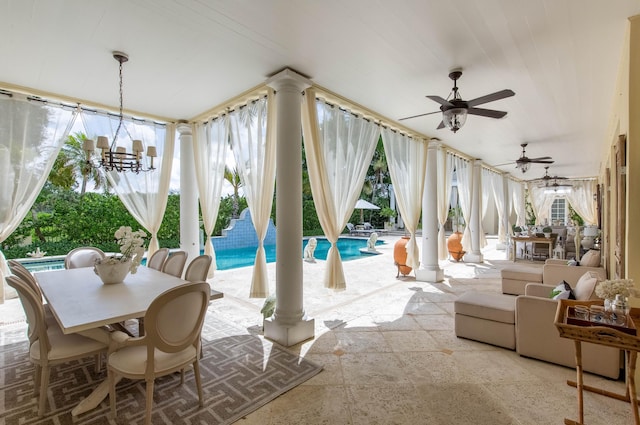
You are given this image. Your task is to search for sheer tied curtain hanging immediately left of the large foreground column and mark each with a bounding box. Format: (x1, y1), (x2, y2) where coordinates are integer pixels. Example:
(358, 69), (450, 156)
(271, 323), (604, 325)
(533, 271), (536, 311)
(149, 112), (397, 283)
(229, 90), (276, 298)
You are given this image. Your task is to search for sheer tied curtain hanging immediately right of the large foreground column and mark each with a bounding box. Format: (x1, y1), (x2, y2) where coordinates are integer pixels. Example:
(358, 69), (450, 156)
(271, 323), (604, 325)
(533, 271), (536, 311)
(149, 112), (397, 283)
(302, 89), (380, 290)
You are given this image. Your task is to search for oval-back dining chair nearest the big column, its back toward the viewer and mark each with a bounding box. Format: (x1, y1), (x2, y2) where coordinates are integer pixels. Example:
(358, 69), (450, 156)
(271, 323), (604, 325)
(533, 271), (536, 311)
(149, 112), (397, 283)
(107, 282), (211, 425)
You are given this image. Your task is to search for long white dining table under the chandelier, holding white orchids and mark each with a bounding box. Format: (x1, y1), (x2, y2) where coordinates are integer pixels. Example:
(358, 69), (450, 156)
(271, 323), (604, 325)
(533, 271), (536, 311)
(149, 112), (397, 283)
(34, 266), (223, 416)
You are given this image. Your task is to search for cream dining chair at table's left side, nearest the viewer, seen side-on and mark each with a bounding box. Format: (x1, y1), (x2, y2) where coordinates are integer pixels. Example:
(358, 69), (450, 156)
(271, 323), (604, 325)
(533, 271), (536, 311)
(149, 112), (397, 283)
(6, 276), (108, 416)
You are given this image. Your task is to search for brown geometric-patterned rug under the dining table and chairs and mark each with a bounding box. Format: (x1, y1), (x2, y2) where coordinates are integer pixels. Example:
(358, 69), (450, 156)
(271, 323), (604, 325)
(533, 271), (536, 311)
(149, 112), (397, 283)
(0, 314), (322, 425)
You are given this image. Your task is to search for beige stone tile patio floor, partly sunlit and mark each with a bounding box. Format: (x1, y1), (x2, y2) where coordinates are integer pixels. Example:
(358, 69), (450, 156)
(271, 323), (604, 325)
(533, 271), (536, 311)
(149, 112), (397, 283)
(0, 236), (633, 425)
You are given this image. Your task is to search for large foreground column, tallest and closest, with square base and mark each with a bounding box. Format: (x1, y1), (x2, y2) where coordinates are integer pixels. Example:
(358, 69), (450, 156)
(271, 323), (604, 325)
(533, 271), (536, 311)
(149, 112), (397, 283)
(264, 69), (315, 347)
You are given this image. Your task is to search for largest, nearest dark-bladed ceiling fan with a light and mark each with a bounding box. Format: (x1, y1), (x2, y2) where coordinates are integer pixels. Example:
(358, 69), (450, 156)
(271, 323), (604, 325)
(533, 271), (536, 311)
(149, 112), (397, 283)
(400, 69), (515, 133)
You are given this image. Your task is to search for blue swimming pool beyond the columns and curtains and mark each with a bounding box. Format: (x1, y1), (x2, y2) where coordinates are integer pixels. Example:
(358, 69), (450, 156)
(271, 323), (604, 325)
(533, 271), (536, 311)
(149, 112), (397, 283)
(21, 238), (384, 272)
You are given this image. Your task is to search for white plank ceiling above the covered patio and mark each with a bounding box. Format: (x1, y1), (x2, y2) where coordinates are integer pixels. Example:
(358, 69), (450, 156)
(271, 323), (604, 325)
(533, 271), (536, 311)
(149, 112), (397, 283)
(0, 0), (640, 178)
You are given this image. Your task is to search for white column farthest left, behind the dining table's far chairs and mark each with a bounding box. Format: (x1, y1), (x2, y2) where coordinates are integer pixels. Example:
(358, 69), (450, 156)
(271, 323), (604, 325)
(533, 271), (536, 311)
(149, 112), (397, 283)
(177, 123), (200, 269)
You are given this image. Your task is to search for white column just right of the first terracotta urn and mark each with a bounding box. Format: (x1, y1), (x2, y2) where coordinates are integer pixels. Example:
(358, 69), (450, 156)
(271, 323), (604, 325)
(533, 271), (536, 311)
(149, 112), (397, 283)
(416, 142), (444, 282)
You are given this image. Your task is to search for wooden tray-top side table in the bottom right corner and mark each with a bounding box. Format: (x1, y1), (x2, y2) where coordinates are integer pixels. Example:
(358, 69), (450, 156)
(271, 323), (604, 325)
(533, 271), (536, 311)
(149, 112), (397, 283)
(555, 300), (640, 425)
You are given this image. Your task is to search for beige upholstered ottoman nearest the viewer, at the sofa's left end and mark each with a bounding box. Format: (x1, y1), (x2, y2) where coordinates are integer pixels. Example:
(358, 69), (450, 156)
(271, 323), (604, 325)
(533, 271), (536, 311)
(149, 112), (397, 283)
(453, 291), (516, 350)
